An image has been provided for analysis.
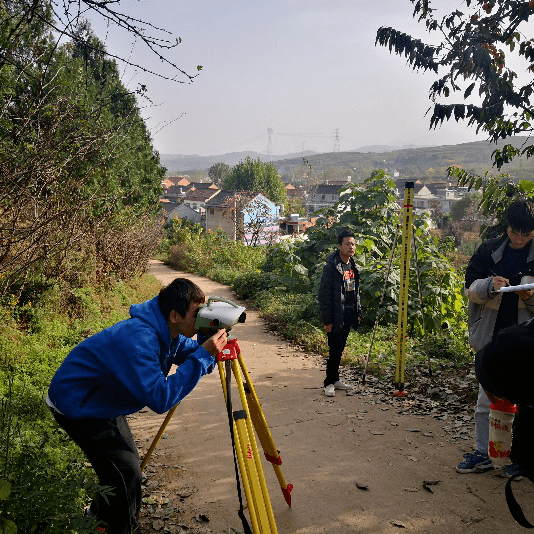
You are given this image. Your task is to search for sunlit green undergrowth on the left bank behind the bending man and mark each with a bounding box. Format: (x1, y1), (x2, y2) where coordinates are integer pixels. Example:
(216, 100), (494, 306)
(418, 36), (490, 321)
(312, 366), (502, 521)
(0, 276), (161, 534)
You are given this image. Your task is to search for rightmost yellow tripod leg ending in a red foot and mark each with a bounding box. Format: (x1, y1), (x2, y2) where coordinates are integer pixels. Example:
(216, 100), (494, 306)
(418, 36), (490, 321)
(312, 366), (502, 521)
(237, 354), (293, 506)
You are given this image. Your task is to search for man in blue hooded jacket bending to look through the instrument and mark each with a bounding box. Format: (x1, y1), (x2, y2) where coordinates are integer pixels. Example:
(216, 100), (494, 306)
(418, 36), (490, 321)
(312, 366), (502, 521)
(46, 278), (226, 534)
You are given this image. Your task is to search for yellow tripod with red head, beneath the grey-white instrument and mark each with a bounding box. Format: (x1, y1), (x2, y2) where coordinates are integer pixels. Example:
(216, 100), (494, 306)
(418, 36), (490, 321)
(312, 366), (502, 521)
(216, 338), (293, 534)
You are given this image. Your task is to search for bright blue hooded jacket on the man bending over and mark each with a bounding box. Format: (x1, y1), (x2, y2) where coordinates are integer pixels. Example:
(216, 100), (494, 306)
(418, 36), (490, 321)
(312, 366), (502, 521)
(48, 297), (215, 419)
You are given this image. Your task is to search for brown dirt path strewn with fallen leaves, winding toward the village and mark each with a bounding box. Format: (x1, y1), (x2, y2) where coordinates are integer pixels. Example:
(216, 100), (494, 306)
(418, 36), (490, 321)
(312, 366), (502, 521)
(130, 262), (534, 534)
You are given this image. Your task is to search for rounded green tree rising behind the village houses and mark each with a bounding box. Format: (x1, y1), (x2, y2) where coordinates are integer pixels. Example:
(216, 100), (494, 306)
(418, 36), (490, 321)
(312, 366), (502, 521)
(222, 158), (287, 206)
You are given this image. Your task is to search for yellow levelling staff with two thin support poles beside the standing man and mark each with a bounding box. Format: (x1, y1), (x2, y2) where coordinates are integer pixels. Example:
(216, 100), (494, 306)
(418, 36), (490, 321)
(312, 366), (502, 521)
(362, 182), (432, 397)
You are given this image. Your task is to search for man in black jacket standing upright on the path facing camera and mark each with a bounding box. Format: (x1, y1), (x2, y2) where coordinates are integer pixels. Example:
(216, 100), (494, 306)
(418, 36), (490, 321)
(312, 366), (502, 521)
(319, 230), (362, 397)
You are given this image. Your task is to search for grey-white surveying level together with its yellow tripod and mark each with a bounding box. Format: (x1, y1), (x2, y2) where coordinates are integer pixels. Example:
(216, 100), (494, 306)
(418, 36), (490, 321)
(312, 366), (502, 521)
(141, 297), (293, 534)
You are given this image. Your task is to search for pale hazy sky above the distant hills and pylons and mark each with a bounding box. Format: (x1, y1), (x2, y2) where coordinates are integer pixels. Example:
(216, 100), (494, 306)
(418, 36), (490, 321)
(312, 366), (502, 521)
(79, 0), (516, 155)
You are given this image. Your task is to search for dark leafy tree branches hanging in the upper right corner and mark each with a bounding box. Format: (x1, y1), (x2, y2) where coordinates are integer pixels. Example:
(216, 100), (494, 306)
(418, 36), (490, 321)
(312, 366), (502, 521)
(376, 0), (534, 169)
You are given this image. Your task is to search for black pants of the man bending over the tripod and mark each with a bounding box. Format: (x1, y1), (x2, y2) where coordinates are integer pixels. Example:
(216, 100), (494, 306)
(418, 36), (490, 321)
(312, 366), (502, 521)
(53, 411), (141, 534)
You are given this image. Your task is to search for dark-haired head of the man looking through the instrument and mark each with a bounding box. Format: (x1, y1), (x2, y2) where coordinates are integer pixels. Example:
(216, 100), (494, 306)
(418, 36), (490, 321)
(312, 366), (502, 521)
(158, 278), (206, 338)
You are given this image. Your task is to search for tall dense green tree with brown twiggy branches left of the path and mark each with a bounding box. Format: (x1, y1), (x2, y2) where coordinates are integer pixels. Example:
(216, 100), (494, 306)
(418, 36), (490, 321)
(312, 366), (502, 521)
(0, 11), (164, 295)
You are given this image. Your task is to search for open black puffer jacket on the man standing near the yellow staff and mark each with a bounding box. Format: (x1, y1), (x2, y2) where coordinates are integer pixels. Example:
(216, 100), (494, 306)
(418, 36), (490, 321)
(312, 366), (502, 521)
(319, 250), (362, 332)
